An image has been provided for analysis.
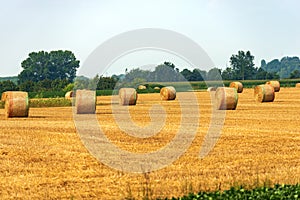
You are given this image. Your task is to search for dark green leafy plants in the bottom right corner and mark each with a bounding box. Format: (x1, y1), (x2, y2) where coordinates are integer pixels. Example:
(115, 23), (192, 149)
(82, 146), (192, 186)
(166, 184), (300, 200)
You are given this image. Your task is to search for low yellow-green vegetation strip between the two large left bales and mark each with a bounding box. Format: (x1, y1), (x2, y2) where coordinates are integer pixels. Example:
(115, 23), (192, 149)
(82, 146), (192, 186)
(29, 98), (72, 108)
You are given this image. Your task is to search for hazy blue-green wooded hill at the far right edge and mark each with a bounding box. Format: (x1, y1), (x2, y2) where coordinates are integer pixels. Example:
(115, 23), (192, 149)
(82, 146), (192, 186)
(261, 57), (300, 78)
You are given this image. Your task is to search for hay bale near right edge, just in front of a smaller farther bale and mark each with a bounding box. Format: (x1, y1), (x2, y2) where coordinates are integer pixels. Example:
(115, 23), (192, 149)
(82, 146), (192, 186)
(254, 84), (275, 102)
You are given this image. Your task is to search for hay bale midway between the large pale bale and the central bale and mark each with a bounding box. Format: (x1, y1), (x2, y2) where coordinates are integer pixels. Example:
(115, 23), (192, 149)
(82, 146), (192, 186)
(119, 88), (138, 106)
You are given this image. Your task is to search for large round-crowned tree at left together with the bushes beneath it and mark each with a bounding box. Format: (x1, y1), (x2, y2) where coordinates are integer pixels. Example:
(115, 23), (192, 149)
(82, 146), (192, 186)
(18, 50), (79, 92)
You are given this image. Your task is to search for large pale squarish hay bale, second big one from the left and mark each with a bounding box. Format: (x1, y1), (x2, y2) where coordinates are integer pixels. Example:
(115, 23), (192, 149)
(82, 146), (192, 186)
(75, 90), (96, 114)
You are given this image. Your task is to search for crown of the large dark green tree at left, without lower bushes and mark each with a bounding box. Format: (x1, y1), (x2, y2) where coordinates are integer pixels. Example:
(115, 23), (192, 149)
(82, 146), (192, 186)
(18, 50), (79, 84)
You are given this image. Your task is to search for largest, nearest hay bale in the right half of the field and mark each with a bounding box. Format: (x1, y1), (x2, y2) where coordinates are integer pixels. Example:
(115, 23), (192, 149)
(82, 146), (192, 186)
(215, 87), (239, 110)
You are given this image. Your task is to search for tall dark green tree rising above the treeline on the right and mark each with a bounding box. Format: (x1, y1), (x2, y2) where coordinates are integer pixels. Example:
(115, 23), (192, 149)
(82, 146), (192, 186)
(230, 51), (256, 80)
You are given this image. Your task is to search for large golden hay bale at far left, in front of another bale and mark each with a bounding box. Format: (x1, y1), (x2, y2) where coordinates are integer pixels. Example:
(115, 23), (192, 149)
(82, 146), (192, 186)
(4, 91), (29, 117)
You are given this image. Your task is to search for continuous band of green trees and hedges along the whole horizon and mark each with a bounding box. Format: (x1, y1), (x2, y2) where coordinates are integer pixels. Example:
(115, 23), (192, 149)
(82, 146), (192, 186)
(0, 50), (300, 93)
